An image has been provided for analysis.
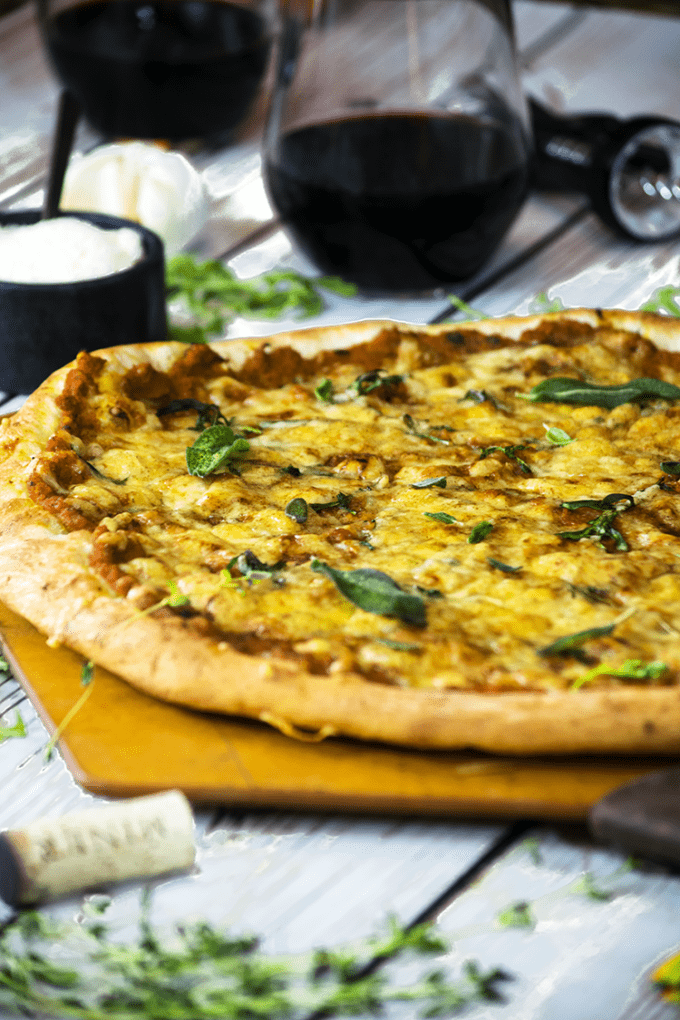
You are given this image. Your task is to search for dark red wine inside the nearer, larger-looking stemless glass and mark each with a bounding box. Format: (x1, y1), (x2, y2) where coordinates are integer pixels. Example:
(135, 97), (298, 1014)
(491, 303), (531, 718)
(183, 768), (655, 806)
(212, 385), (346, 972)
(266, 112), (528, 293)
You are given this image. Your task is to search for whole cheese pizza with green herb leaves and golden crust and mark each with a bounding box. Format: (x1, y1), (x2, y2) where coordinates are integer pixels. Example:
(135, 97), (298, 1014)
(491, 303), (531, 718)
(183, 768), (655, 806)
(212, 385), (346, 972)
(0, 309), (680, 755)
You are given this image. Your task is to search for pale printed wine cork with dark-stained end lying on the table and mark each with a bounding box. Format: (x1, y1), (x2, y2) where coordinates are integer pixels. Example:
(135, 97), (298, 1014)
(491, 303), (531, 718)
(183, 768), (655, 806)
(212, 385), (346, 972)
(0, 791), (196, 906)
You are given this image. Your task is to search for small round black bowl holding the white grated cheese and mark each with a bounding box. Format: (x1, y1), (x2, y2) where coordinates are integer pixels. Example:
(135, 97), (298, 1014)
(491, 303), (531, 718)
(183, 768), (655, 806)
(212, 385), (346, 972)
(0, 210), (167, 393)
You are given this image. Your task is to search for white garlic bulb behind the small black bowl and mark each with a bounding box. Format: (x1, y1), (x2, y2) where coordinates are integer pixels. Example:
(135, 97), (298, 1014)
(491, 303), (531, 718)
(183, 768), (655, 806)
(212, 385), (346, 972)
(60, 142), (208, 255)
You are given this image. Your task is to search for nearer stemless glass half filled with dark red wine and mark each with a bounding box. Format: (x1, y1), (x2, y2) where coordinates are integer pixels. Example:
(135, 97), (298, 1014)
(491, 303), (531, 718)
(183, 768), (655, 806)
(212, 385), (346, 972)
(264, 0), (530, 293)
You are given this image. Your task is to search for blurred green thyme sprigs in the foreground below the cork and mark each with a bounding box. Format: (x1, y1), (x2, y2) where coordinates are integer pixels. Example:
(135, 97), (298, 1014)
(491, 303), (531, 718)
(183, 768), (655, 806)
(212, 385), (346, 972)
(0, 896), (510, 1020)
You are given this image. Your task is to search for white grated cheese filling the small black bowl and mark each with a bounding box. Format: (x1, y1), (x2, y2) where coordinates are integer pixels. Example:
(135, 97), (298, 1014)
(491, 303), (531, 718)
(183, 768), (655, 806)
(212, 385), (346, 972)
(0, 216), (144, 284)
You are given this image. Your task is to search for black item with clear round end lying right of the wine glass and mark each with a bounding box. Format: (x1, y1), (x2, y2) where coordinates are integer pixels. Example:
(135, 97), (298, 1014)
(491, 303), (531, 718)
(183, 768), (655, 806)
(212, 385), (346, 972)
(529, 99), (680, 241)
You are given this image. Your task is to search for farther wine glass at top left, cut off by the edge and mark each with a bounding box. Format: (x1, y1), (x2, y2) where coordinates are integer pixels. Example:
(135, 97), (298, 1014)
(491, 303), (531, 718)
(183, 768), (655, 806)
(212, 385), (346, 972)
(37, 0), (274, 143)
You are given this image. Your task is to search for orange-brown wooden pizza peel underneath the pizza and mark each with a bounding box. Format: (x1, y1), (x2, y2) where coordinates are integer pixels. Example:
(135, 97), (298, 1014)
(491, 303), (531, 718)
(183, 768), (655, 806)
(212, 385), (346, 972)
(0, 604), (680, 828)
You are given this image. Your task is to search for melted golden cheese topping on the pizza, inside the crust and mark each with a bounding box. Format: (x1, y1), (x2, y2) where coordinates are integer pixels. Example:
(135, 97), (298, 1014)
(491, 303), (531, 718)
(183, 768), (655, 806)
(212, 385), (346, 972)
(31, 330), (680, 691)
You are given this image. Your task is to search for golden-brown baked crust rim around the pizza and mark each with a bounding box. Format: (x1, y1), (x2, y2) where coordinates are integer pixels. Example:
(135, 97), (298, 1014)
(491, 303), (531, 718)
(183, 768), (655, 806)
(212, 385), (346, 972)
(0, 309), (680, 755)
